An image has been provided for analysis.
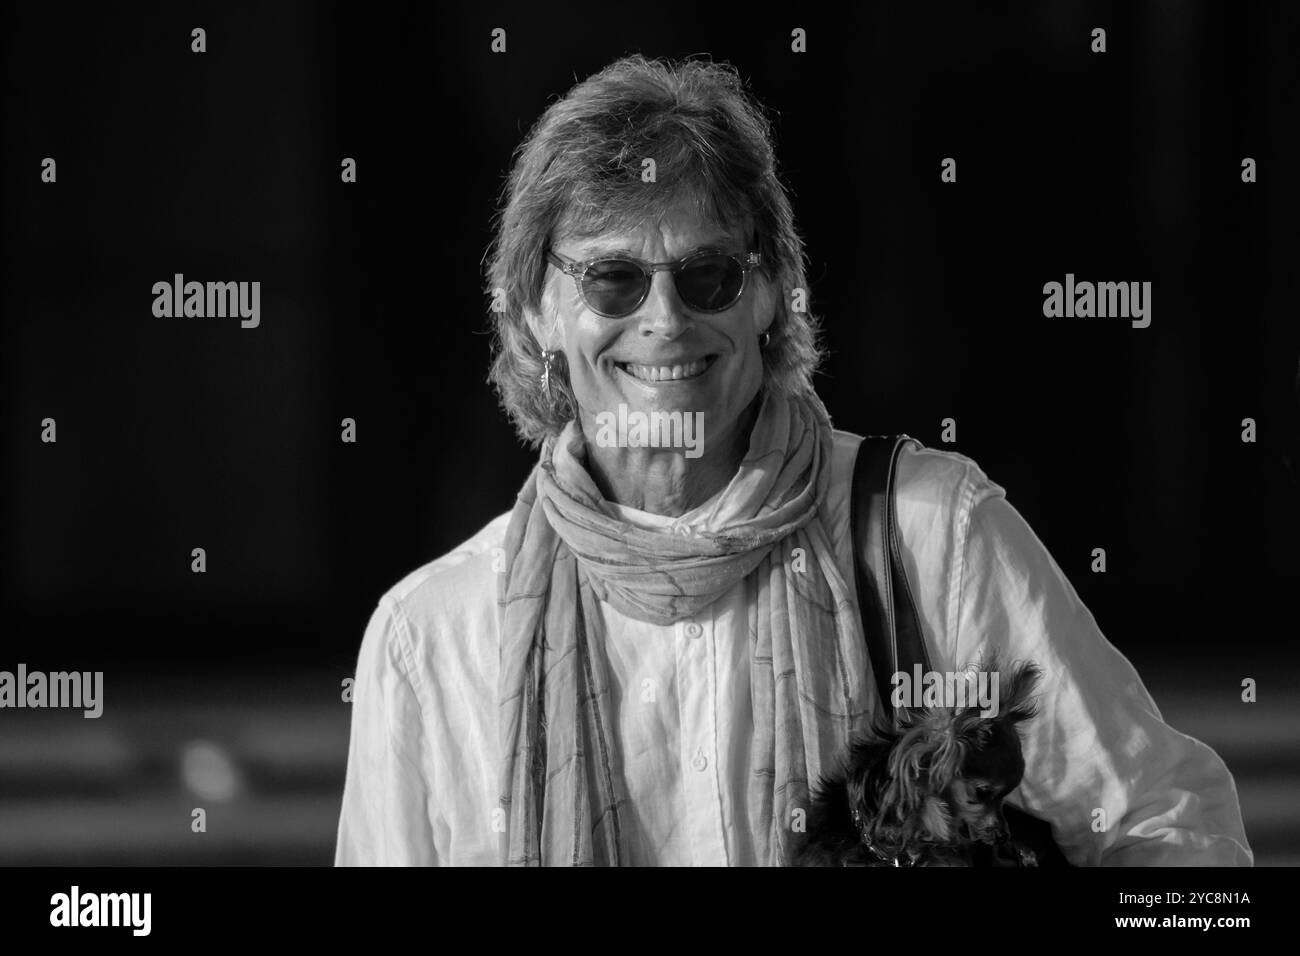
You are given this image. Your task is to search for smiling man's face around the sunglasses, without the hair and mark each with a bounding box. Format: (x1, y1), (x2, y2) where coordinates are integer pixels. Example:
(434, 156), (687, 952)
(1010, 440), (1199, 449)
(534, 207), (775, 446)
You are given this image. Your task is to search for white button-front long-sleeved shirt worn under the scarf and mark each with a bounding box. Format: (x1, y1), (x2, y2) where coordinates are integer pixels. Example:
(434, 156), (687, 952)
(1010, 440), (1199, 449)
(335, 432), (1253, 866)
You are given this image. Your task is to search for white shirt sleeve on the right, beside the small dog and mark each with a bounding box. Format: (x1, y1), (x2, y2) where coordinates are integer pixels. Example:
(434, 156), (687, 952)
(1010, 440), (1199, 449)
(956, 479), (1253, 866)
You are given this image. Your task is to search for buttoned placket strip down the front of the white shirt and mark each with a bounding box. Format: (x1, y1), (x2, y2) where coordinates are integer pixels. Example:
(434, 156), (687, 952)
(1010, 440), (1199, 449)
(676, 614), (728, 866)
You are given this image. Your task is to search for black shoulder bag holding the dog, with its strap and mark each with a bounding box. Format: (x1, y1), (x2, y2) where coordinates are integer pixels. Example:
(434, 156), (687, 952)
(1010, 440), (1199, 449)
(849, 434), (1070, 866)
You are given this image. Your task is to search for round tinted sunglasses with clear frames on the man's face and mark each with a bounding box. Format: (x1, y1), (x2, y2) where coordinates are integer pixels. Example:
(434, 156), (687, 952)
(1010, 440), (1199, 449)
(546, 250), (762, 319)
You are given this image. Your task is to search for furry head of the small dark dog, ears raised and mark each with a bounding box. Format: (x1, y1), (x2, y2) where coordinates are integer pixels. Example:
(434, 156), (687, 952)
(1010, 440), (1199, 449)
(846, 657), (1041, 853)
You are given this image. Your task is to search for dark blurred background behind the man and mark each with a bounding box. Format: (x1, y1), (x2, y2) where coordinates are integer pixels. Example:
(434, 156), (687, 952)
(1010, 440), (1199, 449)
(0, 3), (1300, 864)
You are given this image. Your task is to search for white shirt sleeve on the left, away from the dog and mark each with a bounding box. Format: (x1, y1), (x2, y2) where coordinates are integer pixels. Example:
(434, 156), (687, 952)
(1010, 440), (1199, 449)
(334, 598), (439, 866)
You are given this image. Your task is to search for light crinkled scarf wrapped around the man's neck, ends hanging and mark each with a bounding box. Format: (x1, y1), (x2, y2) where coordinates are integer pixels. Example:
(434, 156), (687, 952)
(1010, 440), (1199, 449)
(498, 390), (876, 866)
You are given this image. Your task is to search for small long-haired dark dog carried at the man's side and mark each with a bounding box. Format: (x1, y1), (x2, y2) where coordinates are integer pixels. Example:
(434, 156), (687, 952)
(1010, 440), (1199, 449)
(796, 657), (1043, 866)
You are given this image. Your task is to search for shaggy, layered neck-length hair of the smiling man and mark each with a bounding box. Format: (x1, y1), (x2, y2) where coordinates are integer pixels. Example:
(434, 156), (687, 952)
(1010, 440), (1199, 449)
(485, 55), (820, 447)
